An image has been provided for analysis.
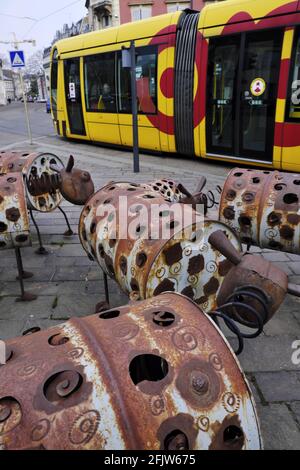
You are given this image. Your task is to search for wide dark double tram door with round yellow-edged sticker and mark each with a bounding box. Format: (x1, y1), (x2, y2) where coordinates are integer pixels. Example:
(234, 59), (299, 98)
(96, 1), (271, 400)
(206, 30), (283, 162)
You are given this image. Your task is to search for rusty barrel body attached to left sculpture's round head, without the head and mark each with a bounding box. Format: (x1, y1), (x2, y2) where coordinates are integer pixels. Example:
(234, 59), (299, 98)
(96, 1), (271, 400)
(0, 151), (64, 212)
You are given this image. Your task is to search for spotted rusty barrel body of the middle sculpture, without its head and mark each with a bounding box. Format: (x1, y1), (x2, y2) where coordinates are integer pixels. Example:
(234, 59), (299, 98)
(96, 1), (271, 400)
(79, 182), (241, 311)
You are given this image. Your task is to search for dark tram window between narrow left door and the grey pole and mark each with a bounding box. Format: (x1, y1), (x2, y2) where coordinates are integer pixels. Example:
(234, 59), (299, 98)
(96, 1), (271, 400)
(84, 53), (117, 113)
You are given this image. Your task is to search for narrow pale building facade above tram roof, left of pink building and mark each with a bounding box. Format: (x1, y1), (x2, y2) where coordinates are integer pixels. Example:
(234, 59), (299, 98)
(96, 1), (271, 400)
(85, 0), (120, 31)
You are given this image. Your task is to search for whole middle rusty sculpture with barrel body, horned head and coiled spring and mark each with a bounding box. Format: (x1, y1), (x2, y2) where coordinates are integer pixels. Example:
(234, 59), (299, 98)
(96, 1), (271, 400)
(79, 180), (300, 354)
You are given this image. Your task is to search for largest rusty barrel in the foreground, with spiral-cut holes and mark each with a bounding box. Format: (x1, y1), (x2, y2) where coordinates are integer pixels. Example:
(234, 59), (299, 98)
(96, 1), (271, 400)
(0, 293), (262, 450)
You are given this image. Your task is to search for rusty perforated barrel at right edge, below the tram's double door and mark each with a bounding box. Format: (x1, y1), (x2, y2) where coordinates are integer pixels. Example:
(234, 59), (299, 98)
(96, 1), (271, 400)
(219, 168), (300, 254)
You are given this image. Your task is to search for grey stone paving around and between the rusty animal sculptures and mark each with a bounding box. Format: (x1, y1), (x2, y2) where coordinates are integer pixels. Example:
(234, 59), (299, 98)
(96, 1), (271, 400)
(0, 136), (300, 449)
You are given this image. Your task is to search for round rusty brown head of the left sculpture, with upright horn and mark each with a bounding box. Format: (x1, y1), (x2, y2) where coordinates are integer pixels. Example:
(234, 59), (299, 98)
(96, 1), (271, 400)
(59, 155), (95, 206)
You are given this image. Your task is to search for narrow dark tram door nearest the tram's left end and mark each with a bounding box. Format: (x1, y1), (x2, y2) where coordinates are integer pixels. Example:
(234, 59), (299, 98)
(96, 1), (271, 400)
(64, 58), (86, 135)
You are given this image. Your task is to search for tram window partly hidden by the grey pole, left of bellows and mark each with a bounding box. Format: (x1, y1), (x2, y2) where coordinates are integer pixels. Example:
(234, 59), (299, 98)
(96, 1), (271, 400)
(118, 47), (157, 114)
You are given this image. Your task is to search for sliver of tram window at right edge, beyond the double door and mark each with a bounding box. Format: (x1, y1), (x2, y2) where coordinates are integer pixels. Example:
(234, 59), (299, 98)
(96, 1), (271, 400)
(288, 31), (300, 120)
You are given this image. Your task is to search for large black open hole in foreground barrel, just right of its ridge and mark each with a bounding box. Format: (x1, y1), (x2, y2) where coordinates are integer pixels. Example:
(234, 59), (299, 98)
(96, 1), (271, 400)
(129, 354), (169, 385)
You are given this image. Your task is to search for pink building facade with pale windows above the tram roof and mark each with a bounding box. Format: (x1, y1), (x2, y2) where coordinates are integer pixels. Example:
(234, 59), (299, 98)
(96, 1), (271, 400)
(120, 0), (220, 23)
